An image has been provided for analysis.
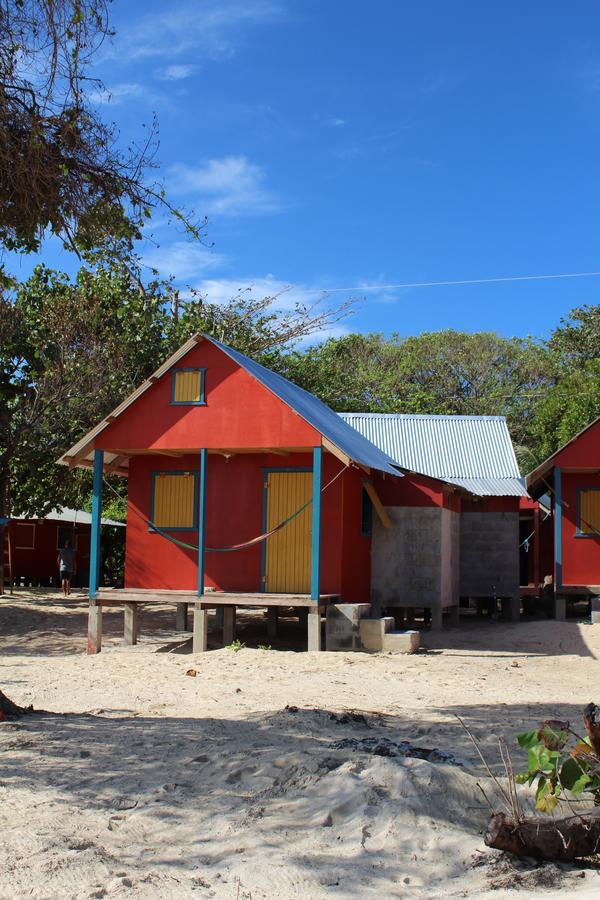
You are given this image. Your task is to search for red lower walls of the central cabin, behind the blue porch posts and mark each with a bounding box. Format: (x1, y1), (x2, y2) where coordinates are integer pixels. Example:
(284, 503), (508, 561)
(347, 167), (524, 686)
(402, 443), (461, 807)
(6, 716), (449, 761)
(125, 453), (371, 601)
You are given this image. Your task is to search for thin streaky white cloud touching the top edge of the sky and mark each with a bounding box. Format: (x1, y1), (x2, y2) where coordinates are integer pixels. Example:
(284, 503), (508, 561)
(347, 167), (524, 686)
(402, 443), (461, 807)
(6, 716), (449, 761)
(107, 0), (283, 61)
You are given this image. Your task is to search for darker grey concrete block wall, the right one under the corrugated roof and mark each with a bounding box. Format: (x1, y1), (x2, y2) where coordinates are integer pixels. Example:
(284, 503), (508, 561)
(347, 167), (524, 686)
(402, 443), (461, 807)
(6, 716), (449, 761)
(459, 512), (519, 597)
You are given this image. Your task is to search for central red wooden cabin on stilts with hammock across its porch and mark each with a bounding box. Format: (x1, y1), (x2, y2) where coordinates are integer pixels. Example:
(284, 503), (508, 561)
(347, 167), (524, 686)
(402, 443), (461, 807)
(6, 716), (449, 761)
(61, 336), (401, 650)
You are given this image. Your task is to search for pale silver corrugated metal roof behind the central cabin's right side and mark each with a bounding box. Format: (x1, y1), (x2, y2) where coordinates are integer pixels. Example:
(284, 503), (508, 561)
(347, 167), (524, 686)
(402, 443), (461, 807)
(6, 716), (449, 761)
(340, 413), (527, 497)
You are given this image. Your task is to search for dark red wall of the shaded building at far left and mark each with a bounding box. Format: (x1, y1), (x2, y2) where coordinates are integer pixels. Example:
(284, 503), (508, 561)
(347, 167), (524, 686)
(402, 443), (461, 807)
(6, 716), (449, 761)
(9, 519), (90, 580)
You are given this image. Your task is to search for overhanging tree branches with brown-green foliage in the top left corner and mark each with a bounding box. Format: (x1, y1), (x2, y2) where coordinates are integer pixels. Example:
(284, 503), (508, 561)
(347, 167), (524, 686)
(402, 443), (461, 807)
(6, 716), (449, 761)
(0, 0), (200, 259)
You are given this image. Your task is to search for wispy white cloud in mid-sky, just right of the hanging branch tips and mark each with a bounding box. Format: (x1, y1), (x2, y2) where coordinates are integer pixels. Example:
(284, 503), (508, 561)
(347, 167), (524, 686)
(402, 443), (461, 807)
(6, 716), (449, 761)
(168, 156), (280, 216)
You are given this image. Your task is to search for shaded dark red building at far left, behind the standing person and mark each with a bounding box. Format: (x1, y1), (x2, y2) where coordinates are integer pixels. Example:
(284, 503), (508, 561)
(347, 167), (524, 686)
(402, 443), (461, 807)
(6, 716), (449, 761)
(4, 508), (123, 587)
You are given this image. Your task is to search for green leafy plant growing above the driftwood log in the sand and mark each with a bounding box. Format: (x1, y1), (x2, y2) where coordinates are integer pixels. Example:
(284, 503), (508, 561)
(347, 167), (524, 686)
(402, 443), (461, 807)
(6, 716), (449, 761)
(515, 719), (600, 813)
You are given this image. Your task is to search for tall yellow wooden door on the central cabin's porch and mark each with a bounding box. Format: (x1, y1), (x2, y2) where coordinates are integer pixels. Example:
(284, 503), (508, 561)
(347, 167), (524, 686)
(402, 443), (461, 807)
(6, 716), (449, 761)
(265, 472), (312, 594)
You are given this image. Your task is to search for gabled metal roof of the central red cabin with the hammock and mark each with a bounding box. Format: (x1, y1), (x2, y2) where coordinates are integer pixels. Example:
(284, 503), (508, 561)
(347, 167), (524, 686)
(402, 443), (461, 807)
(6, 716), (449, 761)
(58, 334), (401, 477)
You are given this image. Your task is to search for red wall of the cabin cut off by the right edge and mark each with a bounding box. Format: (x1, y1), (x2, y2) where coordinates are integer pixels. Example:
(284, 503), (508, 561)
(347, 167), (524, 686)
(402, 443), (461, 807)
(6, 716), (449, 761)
(562, 468), (600, 585)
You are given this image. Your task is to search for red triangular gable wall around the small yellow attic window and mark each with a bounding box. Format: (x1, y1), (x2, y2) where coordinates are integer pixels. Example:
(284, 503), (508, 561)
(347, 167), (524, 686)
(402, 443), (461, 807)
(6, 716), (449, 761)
(95, 341), (321, 450)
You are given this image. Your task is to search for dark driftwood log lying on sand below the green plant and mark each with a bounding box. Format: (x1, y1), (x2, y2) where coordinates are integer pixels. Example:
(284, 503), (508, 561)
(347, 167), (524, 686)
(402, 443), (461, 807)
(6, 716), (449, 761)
(484, 813), (600, 860)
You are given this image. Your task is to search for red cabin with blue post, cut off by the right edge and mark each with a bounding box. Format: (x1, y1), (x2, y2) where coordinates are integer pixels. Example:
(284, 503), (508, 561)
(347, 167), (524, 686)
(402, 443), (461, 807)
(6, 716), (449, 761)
(527, 419), (600, 615)
